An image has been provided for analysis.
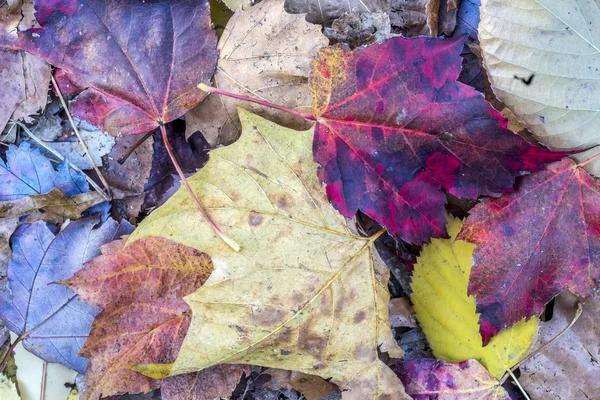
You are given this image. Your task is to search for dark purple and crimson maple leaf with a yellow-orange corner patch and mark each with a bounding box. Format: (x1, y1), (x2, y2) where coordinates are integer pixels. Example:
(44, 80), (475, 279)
(311, 37), (564, 244)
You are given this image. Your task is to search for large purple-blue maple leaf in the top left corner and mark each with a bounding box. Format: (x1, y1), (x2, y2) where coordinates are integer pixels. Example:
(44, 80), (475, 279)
(0, 0), (217, 135)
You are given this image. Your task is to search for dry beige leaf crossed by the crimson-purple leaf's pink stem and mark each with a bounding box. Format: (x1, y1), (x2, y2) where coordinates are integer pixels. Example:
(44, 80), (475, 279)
(186, 0), (328, 146)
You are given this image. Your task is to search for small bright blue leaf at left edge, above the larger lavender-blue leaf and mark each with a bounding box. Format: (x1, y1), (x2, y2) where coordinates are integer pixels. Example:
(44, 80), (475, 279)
(0, 142), (89, 201)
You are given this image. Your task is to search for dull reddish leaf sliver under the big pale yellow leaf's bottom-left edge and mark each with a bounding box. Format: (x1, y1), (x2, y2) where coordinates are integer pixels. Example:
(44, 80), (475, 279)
(160, 365), (251, 400)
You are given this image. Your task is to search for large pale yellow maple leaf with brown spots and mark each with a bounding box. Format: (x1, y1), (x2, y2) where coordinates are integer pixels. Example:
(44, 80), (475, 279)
(129, 109), (407, 400)
